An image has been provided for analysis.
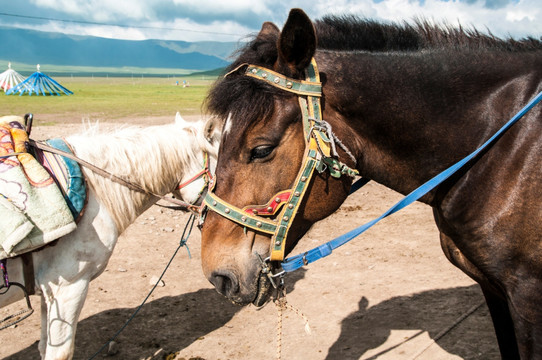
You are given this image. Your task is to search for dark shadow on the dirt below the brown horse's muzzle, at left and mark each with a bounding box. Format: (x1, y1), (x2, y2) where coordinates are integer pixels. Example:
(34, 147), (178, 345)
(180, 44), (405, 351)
(5, 270), (306, 360)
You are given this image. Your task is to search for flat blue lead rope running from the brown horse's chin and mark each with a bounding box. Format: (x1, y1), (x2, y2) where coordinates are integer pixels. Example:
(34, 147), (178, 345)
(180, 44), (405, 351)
(282, 92), (542, 272)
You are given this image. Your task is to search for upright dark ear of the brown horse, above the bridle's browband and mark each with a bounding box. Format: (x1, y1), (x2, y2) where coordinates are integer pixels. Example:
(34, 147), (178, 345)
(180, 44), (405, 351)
(278, 9), (316, 72)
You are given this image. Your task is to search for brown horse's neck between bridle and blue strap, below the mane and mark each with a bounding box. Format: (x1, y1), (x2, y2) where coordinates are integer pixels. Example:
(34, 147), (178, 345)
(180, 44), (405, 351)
(317, 50), (542, 203)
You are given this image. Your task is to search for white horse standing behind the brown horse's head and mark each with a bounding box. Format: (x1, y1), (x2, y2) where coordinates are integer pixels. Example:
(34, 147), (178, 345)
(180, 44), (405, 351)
(0, 114), (219, 359)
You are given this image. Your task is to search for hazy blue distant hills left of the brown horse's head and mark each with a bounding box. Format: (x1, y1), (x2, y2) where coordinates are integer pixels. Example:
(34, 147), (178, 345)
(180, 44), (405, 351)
(0, 27), (238, 71)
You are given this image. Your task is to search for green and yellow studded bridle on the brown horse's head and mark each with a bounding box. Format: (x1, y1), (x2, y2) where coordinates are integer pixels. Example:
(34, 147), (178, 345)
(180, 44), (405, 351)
(202, 59), (358, 262)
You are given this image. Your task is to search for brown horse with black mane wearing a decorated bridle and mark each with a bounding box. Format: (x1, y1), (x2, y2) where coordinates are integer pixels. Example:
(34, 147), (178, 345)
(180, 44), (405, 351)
(202, 9), (542, 359)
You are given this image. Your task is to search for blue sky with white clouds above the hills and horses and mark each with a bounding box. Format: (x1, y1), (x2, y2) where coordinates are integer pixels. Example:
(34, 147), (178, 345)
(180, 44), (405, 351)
(0, 0), (542, 41)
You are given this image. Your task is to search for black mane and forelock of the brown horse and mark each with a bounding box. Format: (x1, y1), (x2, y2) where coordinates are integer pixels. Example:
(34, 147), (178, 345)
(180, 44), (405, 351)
(206, 15), (542, 122)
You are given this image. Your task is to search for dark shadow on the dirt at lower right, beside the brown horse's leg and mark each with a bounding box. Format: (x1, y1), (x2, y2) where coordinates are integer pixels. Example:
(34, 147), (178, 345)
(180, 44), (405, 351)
(326, 285), (500, 360)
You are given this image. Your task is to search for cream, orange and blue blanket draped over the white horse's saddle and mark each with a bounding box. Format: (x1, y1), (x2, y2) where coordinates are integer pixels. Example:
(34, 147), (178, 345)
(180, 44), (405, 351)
(0, 117), (86, 259)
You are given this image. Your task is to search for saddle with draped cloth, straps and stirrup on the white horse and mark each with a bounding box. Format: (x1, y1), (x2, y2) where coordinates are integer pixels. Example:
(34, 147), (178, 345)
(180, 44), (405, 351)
(0, 114), (87, 330)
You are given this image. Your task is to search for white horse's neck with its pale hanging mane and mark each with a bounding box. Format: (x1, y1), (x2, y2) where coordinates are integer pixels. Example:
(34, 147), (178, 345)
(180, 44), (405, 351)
(66, 125), (201, 234)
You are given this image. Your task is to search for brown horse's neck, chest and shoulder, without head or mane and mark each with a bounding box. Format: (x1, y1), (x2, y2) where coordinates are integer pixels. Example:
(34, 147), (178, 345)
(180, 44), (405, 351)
(324, 38), (542, 358)
